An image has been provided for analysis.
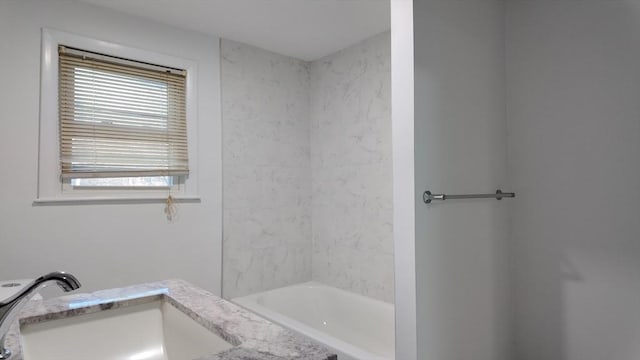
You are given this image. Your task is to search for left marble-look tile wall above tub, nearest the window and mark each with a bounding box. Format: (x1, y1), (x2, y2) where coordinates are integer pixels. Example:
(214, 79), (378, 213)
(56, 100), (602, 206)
(221, 40), (311, 298)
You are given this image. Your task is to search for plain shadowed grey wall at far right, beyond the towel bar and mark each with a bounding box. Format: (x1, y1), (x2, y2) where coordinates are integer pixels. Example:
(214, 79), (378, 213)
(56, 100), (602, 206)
(507, 0), (640, 360)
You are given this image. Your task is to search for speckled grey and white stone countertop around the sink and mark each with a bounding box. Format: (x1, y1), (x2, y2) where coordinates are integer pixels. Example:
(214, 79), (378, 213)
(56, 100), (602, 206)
(5, 280), (335, 360)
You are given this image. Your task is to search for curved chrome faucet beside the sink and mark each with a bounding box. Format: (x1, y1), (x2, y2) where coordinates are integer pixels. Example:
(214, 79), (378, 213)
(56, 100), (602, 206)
(0, 271), (80, 360)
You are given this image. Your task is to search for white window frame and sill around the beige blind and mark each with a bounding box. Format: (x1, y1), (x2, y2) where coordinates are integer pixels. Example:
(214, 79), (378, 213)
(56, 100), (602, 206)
(35, 28), (199, 203)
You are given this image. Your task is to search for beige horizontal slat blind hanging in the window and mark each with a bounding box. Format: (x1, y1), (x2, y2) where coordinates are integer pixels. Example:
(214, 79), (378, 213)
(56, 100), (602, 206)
(58, 46), (189, 179)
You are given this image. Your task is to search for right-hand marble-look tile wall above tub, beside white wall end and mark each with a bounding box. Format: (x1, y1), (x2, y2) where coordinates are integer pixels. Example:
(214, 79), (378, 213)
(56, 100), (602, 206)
(310, 32), (394, 302)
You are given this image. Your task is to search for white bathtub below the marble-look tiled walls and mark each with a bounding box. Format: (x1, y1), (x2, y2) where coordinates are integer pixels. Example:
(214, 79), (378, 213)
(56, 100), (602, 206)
(232, 281), (395, 360)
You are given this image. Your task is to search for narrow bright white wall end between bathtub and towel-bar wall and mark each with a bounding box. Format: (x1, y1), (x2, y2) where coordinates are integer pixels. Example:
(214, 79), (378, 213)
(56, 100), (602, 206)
(391, 0), (418, 360)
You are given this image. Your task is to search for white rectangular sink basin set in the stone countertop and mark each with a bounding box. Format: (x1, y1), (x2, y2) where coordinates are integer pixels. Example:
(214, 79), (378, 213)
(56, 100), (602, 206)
(20, 298), (233, 360)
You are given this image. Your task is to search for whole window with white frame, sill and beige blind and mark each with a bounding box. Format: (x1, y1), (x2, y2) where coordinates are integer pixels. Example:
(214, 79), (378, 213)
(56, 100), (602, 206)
(36, 29), (198, 203)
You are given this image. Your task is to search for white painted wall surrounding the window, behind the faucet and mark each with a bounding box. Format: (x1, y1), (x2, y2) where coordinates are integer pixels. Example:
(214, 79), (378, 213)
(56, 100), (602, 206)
(0, 0), (222, 293)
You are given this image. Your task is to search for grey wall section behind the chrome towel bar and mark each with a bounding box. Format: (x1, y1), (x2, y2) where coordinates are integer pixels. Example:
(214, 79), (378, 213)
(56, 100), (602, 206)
(410, 0), (510, 360)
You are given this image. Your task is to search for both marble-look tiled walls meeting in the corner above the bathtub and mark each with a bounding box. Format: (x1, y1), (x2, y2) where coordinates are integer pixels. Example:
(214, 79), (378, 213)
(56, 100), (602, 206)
(221, 33), (393, 302)
